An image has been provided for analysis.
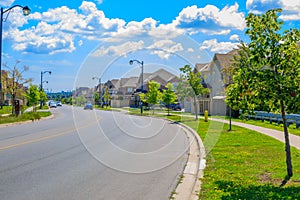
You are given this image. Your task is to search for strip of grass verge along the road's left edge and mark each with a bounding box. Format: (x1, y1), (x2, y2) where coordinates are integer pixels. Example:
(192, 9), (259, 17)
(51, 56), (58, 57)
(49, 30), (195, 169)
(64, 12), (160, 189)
(0, 111), (51, 124)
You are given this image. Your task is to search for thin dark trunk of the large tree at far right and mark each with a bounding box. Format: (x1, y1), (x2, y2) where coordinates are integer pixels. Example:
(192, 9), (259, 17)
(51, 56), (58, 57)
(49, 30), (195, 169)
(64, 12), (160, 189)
(280, 100), (293, 180)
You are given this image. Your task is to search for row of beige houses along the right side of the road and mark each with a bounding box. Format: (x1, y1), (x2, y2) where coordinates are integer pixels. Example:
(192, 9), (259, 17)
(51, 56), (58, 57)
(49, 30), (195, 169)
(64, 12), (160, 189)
(74, 50), (237, 115)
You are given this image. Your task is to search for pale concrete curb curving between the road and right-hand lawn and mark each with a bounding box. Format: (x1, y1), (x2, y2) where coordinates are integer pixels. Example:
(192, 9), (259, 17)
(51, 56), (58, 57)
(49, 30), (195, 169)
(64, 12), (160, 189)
(171, 123), (206, 200)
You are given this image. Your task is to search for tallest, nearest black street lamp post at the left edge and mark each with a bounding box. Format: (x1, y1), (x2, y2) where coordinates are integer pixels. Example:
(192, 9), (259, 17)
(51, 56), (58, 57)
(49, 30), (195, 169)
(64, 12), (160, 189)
(0, 5), (30, 109)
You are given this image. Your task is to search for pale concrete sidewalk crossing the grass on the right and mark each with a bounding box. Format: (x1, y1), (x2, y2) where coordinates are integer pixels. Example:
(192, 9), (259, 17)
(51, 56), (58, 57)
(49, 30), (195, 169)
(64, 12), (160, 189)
(210, 118), (300, 150)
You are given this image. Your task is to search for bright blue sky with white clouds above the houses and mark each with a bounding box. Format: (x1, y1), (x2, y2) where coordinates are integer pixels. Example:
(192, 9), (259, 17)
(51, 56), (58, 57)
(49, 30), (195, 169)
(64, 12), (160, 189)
(0, 0), (300, 91)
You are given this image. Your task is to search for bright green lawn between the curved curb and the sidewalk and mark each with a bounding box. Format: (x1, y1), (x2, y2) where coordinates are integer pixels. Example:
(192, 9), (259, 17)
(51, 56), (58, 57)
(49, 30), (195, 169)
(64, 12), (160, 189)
(166, 116), (300, 199)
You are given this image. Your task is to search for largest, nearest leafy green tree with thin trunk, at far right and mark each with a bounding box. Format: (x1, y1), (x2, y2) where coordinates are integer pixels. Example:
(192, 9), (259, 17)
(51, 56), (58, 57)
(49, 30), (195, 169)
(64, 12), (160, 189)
(226, 9), (300, 184)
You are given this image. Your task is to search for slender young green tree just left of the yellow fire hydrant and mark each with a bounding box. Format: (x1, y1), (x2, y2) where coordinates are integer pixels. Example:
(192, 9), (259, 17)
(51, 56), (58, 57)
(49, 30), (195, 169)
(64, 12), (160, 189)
(180, 65), (209, 120)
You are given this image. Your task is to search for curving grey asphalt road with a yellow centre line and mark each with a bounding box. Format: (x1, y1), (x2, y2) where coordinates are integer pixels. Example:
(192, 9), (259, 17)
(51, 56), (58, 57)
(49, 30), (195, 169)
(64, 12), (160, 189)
(0, 106), (188, 200)
